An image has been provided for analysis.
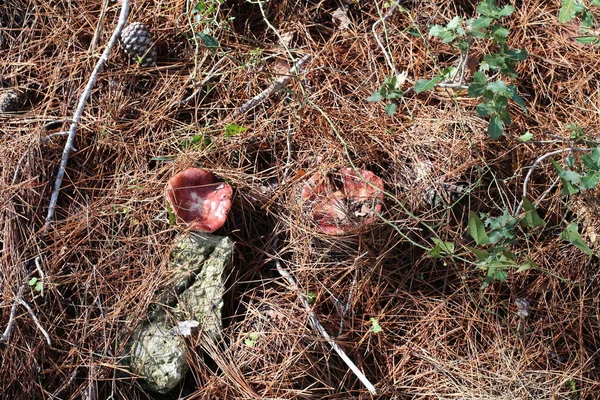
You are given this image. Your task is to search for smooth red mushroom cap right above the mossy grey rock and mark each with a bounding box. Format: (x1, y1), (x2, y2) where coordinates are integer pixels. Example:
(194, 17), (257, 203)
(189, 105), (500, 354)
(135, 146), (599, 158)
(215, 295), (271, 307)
(166, 168), (233, 232)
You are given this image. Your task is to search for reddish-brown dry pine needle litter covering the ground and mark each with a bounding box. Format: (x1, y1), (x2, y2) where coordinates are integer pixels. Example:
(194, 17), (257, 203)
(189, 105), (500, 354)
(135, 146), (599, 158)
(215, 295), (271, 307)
(0, 0), (600, 400)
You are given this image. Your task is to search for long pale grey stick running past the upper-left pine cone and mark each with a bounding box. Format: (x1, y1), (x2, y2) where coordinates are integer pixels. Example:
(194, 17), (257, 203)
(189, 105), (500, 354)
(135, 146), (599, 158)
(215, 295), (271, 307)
(42, 0), (129, 234)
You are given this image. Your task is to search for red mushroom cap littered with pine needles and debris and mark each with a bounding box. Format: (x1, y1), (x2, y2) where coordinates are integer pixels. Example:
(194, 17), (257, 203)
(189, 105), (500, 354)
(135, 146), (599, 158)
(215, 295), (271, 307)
(300, 168), (383, 235)
